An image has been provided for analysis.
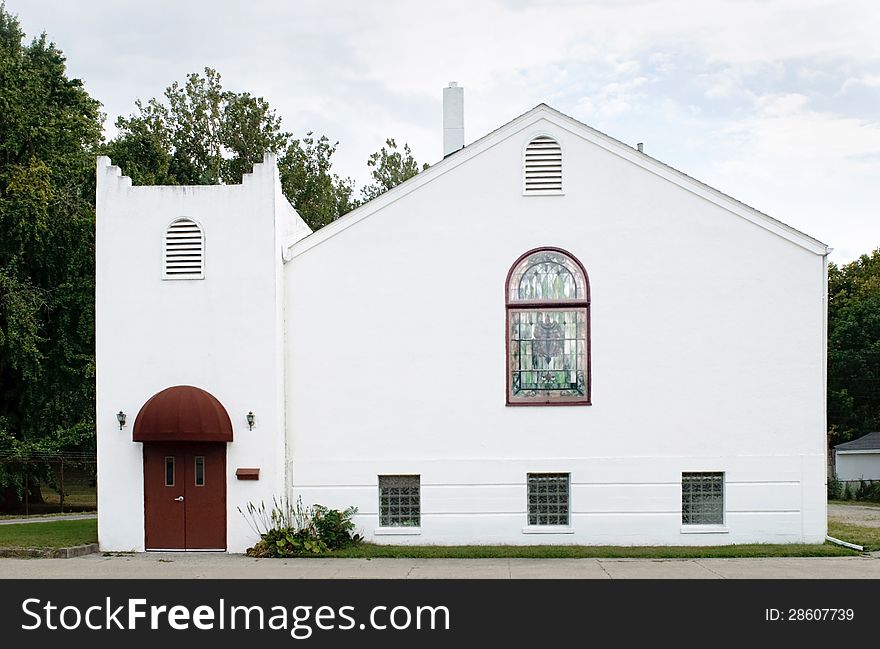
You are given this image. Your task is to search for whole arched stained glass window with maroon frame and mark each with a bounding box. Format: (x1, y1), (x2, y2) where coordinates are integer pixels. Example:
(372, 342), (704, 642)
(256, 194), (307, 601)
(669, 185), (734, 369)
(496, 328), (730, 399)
(506, 248), (590, 405)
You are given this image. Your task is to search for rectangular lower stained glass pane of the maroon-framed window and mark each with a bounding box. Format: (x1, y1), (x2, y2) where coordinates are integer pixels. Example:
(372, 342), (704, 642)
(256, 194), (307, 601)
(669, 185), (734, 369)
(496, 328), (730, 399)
(509, 308), (587, 401)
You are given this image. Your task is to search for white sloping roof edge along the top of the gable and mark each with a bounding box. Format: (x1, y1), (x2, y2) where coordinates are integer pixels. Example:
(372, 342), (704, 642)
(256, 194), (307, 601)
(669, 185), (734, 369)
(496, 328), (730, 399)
(284, 104), (831, 261)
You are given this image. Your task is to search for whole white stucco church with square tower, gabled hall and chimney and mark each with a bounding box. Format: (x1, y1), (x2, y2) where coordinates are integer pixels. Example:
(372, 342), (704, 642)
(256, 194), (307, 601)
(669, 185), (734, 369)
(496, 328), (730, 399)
(96, 87), (829, 552)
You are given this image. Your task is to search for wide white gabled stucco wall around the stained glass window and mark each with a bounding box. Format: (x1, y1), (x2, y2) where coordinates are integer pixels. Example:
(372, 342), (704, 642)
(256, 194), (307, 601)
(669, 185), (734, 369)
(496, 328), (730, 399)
(286, 116), (826, 545)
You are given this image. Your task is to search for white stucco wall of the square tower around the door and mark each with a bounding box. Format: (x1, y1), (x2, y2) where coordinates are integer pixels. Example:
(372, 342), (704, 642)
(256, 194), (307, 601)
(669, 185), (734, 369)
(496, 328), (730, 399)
(96, 157), (308, 552)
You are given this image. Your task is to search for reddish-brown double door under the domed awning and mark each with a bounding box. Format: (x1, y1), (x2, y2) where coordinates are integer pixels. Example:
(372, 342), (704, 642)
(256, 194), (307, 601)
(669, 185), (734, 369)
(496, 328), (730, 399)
(144, 442), (226, 550)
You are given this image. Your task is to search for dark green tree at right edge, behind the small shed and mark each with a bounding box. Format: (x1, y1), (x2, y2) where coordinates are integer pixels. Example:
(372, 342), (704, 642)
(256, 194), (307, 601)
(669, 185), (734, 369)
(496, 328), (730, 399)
(828, 248), (880, 445)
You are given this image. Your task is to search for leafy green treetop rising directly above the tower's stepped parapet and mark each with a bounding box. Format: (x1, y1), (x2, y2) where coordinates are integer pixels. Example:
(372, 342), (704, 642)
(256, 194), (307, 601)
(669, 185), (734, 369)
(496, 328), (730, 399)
(106, 68), (290, 185)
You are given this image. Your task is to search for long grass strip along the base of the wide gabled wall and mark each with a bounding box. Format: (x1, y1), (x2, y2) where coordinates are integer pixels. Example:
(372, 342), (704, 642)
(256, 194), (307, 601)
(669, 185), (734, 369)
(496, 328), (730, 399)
(326, 543), (858, 559)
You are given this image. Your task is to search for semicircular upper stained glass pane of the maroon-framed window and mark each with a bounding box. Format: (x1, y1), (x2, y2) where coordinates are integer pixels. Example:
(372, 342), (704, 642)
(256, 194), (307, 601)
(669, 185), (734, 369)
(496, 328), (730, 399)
(508, 250), (587, 302)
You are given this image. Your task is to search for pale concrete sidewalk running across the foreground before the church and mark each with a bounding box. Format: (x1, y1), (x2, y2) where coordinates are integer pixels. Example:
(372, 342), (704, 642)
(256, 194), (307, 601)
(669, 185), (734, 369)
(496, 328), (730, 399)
(0, 553), (880, 579)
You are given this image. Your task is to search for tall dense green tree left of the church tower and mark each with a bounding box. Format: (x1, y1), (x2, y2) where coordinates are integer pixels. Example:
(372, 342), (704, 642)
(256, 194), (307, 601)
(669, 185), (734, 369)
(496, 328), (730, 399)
(0, 5), (101, 498)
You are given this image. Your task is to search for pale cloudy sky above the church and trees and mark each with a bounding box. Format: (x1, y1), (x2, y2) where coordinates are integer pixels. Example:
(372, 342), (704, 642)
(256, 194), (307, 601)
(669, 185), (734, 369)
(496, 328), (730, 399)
(6, 0), (880, 262)
